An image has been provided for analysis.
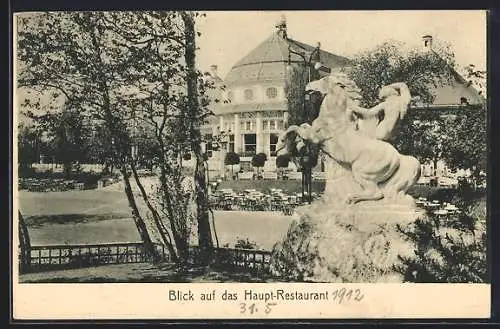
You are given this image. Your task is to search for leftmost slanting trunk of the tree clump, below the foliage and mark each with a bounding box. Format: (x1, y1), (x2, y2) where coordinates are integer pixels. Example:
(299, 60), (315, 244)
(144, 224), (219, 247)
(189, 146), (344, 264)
(120, 164), (161, 263)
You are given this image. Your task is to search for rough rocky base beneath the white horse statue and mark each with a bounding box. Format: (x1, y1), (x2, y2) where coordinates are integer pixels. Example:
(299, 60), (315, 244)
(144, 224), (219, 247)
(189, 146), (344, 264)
(271, 177), (421, 283)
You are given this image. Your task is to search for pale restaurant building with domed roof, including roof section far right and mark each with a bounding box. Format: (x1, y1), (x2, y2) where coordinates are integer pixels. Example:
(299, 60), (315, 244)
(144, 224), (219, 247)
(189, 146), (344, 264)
(198, 19), (484, 178)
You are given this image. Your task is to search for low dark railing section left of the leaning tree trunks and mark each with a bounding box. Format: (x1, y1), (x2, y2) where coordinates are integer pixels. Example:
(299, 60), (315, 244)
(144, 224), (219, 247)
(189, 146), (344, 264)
(26, 242), (170, 271)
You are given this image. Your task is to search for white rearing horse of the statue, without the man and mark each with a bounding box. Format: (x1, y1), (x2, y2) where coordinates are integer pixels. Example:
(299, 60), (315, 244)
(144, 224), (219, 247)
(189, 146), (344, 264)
(282, 75), (420, 203)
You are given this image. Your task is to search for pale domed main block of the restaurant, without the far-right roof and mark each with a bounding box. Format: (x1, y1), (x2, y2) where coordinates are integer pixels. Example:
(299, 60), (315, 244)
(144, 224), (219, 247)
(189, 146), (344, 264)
(201, 20), (349, 171)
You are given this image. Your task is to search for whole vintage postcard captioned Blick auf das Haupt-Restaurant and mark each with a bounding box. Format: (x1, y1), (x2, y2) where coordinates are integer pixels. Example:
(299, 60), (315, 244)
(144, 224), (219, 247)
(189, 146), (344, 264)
(12, 10), (491, 320)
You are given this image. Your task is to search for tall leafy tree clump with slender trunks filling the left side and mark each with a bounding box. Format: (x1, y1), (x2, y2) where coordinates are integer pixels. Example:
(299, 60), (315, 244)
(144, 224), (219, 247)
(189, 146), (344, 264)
(18, 12), (217, 262)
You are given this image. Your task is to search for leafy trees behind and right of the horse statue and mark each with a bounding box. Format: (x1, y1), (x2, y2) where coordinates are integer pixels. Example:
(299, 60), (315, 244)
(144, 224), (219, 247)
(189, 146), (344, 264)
(349, 42), (487, 182)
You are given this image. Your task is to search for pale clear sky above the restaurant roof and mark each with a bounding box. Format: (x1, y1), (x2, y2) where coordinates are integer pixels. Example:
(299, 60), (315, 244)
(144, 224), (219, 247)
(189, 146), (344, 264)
(197, 10), (487, 78)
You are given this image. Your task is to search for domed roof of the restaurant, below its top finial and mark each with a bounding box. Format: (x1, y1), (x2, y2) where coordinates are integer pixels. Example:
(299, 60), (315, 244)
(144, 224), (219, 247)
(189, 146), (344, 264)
(224, 33), (349, 85)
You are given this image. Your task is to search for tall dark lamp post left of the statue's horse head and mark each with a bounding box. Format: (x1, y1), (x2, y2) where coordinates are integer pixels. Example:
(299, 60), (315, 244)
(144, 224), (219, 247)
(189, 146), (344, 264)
(288, 44), (324, 204)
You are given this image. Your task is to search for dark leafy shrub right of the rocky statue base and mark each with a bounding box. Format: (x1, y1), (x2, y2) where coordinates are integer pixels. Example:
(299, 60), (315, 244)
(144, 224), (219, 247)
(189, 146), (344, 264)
(397, 196), (490, 283)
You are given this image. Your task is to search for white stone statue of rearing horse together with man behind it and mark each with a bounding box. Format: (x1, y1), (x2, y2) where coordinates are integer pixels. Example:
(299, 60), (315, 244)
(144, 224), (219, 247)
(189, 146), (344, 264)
(282, 74), (420, 204)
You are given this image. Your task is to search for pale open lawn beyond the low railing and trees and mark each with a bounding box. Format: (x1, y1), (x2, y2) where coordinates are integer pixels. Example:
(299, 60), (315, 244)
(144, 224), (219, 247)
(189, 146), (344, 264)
(19, 190), (294, 250)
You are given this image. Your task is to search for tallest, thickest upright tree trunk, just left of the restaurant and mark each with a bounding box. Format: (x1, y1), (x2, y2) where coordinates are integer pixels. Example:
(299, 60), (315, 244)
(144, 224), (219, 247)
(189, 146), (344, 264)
(182, 12), (213, 265)
